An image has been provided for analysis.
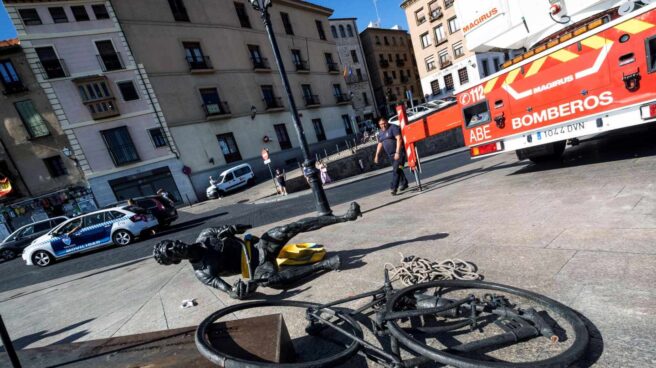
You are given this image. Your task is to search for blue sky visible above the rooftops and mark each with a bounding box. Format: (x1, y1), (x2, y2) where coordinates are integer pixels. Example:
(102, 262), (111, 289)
(0, 0), (408, 40)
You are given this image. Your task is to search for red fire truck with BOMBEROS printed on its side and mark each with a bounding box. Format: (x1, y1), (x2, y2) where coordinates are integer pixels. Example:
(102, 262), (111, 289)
(400, 1), (656, 167)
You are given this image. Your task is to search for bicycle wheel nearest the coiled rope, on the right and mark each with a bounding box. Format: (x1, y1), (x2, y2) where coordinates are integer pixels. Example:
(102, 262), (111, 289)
(386, 280), (589, 368)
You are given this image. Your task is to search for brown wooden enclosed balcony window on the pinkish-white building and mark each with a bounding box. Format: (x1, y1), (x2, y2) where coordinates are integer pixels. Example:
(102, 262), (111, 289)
(76, 76), (119, 119)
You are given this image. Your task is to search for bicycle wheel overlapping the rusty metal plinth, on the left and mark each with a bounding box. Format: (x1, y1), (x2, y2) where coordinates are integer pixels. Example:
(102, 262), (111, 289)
(196, 300), (362, 368)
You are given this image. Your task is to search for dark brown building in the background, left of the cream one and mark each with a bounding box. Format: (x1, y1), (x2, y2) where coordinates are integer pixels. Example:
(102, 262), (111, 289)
(360, 27), (423, 116)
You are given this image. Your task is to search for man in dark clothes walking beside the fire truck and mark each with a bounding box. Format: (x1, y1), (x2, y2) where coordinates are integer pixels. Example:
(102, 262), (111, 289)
(374, 118), (408, 195)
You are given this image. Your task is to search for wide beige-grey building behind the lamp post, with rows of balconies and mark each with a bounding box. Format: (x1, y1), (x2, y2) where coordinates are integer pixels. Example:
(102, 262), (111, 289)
(112, 0), (354, 193)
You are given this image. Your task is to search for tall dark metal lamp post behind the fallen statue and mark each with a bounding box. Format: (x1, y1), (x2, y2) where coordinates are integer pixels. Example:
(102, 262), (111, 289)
(249, 0), (332, 216)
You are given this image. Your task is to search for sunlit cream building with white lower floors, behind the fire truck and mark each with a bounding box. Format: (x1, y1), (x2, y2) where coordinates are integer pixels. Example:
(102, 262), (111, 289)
(401, 0), (514, 98)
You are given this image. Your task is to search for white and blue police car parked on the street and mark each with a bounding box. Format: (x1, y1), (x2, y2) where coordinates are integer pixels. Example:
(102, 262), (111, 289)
(23, 207), (158, 267)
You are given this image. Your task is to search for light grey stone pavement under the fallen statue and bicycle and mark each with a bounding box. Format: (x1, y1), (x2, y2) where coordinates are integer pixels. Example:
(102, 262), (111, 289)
(0, 147), (656, 367)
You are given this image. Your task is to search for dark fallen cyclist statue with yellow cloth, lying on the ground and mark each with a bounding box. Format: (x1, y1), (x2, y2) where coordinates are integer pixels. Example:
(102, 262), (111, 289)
(153, 202), (362, 299)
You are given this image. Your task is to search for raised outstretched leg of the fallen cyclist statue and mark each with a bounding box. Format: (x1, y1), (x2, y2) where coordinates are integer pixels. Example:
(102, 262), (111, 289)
(260, 202), (362, 258)
